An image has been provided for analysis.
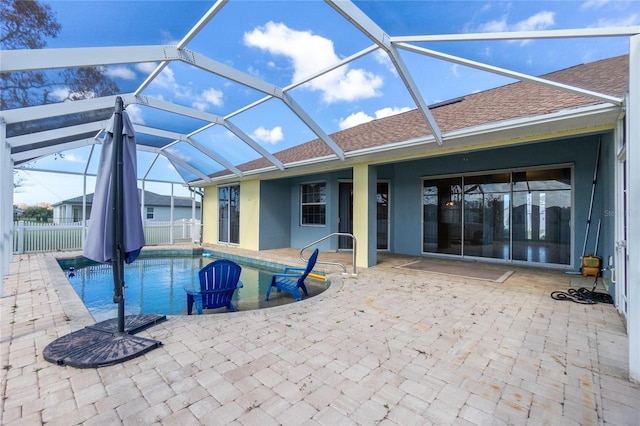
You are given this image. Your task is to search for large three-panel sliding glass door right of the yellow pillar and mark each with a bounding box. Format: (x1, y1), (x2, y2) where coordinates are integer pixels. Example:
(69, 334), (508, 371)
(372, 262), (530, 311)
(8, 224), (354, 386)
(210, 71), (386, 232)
(422, 167), (572, 265)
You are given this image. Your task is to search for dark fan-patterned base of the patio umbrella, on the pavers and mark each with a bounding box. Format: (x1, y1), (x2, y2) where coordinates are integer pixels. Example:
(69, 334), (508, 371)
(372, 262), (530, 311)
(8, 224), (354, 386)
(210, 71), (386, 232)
(42, 315), (167, 368)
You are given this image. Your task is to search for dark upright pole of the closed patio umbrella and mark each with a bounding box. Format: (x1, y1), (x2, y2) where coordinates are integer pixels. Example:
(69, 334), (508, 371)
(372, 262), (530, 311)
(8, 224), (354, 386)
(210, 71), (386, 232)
(110, 96), (124, 334)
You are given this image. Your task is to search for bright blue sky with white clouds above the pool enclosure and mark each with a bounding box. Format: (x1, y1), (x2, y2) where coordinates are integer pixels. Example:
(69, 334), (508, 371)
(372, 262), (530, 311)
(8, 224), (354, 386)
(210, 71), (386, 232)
(14, 0), (640, 204)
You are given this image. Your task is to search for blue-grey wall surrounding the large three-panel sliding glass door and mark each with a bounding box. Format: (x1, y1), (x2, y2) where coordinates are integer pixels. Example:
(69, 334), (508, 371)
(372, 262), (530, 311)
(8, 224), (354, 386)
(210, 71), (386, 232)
(388, 133), (614, 266)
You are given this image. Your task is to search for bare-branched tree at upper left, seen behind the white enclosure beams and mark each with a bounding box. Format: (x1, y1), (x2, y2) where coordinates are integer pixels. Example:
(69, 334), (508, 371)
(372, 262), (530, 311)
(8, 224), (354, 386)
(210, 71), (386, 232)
(0, 0), (119, 110)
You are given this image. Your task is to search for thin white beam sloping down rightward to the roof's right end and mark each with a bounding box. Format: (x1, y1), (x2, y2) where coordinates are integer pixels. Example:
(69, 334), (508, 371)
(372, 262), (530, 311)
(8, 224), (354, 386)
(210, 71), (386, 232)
(398, 43), (623, 105)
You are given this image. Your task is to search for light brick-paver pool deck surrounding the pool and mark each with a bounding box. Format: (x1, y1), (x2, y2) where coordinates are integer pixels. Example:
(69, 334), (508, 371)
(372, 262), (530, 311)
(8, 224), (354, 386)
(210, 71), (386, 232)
(0, 247), (640, 426)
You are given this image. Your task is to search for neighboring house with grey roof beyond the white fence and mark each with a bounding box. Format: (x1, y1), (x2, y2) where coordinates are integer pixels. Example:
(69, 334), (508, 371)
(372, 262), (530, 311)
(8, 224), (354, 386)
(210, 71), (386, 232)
(52, 189), (200, 223)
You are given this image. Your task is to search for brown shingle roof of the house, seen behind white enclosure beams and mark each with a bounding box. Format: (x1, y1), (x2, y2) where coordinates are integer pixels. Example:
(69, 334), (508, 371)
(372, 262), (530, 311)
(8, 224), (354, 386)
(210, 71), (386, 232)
(228, 55), (629, 176)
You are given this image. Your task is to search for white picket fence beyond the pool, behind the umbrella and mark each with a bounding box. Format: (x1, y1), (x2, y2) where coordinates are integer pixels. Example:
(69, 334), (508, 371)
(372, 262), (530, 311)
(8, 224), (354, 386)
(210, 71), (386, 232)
(12, 219), (201, 254)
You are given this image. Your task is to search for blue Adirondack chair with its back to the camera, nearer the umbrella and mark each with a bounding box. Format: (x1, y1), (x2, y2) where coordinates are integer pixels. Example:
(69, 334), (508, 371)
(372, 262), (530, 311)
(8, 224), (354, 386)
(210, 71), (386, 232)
(184, 259), (243, 315)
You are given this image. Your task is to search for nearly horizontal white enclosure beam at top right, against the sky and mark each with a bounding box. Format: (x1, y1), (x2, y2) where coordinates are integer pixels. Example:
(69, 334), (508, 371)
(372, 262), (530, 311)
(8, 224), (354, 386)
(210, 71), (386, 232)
(391, 26), (640, 43)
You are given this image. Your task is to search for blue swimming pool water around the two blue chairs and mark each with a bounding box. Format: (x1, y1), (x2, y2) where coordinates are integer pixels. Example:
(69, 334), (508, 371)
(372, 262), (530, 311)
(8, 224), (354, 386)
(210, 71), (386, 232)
(63, 257), (327, 322)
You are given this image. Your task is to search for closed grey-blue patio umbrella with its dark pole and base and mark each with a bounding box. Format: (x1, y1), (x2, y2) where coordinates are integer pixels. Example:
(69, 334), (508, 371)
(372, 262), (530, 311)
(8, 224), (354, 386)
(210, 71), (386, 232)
(43, 97), (166, 368)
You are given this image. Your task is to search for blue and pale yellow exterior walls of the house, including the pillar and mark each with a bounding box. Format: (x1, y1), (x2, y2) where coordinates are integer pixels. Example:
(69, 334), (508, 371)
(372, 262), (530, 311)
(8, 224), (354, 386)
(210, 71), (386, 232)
(204, 131), (616, 269)
